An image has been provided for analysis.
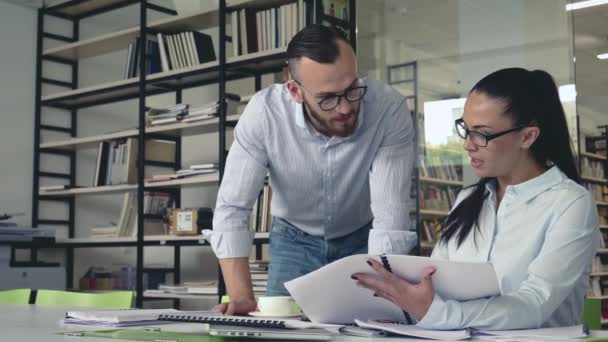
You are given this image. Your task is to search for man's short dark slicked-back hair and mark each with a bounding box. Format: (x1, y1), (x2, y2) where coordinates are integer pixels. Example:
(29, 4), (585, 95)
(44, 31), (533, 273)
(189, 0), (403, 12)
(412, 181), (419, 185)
(287, 24), (350, 75)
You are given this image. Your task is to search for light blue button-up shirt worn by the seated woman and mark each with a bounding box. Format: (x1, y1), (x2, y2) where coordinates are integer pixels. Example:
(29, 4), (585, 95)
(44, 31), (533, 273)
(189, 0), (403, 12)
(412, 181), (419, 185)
(418, 166), (601, 330)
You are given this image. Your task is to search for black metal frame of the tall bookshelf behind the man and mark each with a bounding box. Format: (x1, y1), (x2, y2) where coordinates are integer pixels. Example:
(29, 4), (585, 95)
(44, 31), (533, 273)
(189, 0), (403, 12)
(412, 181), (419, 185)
(30, 0), (356, 307)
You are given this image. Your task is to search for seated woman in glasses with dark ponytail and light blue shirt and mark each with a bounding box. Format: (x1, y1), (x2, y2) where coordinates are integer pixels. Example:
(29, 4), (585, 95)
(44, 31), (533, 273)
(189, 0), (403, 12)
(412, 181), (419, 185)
(353, 68), (601, 330)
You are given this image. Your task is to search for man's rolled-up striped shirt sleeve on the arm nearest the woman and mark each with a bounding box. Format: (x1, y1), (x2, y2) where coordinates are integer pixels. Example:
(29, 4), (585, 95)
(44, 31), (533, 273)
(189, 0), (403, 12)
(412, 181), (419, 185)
(368, 99), (417, 254)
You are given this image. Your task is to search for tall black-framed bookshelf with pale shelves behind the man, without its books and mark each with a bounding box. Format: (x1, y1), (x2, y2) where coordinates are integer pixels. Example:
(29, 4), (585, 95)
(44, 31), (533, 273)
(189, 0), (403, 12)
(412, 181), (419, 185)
(26, 0), (355, 307)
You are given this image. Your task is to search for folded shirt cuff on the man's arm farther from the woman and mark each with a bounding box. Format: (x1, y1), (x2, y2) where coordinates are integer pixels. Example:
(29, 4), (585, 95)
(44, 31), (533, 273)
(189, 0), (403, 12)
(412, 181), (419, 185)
(202, 229), (255, 259)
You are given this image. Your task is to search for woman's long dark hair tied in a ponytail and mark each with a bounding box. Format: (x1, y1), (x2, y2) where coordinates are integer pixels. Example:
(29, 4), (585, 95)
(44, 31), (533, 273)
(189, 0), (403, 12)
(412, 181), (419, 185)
(441, 68), (580, 246)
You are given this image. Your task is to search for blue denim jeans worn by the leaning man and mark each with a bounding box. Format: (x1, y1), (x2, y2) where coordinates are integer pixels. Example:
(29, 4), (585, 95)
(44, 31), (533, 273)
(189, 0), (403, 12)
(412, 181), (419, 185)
(266, 217), (372, 296)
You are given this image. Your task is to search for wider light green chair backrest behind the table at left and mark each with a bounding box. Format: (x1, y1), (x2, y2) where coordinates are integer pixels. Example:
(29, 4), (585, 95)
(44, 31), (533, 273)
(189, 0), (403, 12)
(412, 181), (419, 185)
(36, 290), (133, 309)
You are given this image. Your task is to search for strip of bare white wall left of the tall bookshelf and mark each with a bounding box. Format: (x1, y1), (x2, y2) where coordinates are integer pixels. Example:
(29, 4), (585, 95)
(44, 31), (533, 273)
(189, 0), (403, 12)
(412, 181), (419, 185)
(0, 2), (36, 224)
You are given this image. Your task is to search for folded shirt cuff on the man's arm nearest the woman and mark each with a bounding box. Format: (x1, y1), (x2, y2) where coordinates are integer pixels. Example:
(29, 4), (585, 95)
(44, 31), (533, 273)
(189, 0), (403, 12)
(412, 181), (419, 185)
(367, 228), (418, 255)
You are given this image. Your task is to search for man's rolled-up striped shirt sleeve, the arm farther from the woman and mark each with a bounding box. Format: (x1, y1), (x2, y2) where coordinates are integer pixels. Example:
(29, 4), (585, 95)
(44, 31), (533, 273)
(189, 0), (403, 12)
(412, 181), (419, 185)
(206, 96), (268, 259)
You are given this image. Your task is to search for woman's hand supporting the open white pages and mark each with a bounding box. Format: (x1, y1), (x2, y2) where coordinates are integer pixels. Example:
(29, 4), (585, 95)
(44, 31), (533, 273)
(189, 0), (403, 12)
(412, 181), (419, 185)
(351, 259), (435, 320)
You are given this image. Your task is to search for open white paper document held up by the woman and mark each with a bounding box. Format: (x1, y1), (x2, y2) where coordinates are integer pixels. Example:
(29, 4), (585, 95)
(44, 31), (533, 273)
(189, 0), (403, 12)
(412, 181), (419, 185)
(285, 254), (500, 324)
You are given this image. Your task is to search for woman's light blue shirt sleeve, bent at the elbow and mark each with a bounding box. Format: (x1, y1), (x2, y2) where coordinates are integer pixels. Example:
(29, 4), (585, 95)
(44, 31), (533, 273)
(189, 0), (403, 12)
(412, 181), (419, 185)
(418, 193), (599, 330)
